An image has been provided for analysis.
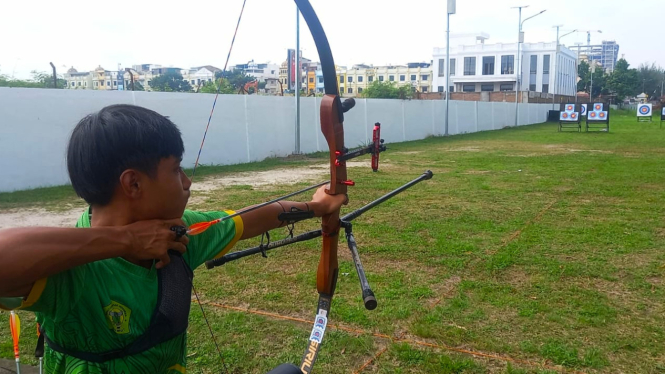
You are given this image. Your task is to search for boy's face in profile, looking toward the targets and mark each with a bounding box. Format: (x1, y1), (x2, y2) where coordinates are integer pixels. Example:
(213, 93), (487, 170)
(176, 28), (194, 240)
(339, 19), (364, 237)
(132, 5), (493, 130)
(140, 156), (192, 219)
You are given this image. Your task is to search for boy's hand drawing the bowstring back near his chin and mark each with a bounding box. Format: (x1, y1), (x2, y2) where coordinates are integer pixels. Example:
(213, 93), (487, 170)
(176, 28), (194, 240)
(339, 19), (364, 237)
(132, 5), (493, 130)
(121, 219), (189, 269)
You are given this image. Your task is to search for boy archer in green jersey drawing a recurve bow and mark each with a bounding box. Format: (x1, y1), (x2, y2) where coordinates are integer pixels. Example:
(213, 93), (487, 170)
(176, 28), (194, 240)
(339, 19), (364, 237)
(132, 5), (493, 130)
(0, 105), (347, 374)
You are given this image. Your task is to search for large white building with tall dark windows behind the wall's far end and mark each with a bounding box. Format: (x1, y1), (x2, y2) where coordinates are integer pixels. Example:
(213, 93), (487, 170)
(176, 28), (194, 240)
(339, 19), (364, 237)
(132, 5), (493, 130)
(432, 33), (577, 96)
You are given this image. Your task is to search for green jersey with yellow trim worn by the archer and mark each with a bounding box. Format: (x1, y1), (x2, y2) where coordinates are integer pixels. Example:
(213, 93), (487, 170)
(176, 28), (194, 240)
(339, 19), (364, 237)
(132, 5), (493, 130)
(0, 211), (243, 374)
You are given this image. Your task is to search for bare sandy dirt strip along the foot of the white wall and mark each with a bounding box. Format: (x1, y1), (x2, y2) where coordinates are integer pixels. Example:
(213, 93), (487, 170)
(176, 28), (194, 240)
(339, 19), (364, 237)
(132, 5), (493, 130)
(0, 161), (376, 229)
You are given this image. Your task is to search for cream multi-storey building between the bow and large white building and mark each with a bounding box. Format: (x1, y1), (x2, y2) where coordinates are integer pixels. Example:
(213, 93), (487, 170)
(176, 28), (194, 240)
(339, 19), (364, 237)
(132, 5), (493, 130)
(337, 62), (432, 97)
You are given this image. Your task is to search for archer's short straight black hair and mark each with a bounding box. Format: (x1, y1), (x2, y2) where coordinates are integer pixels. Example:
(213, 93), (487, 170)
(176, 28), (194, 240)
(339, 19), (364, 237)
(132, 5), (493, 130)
(67, 104), (185, 206)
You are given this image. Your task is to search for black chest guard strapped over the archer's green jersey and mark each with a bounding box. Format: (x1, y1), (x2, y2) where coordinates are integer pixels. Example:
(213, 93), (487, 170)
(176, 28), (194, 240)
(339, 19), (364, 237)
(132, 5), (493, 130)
(37, 251), (194, 363)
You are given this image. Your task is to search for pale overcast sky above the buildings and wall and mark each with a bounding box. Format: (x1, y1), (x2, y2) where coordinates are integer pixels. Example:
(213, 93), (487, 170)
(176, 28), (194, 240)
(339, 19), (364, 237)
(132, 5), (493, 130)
(0, 0), (665, 78)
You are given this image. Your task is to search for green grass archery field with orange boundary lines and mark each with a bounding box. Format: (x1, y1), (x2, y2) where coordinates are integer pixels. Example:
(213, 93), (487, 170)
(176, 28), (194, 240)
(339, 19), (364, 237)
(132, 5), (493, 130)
(0, 113), (665, 373)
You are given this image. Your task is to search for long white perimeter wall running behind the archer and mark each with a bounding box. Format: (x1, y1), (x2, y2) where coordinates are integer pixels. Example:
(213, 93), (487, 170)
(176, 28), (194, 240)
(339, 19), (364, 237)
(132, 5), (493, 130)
(0, 87), (552, 192)
